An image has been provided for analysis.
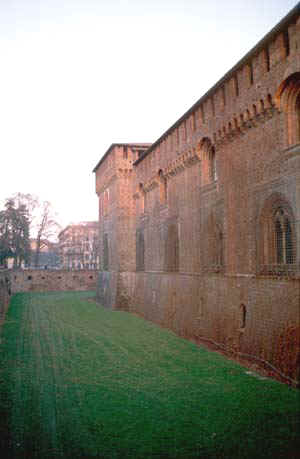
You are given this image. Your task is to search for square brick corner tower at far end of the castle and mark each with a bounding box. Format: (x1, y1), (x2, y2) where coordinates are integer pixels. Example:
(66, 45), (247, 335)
(94, 143), (150, 309)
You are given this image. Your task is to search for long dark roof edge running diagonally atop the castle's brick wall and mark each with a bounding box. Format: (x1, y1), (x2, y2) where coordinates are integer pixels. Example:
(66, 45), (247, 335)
(133, 2), (300, 166)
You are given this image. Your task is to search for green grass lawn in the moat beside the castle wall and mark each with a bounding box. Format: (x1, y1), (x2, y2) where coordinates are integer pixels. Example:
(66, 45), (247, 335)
(0, 292), (300, 459)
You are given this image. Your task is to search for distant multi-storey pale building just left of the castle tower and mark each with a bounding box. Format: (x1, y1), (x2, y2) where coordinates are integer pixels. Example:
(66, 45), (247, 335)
(58, 222), (99, 269)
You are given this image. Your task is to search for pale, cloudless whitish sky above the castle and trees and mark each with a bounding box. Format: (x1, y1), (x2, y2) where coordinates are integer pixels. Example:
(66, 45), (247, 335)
(0, 0), (297, 232)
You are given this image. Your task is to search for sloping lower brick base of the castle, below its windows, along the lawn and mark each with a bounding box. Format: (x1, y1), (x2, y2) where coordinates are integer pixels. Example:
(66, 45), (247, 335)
(97, 272), (300, 379)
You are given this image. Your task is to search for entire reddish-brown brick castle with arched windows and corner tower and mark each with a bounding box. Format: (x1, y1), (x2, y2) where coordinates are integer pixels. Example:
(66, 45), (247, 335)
(94, 4), (300, 378)
